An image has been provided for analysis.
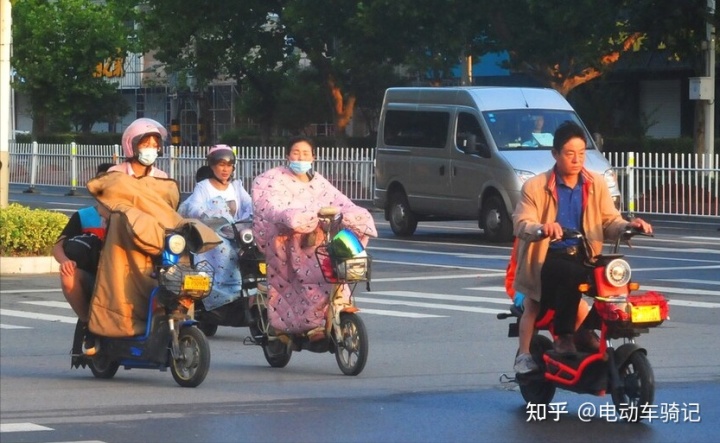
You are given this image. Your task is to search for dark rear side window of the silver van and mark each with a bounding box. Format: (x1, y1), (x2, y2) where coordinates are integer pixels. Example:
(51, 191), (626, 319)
(383, 110), (450, 149)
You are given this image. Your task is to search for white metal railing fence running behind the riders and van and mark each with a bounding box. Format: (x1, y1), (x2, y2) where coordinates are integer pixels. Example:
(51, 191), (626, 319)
(9, 143), (720, 217)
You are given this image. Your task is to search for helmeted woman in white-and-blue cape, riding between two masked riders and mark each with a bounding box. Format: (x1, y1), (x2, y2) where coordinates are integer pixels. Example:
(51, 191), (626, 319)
(178, 145), (252, 310)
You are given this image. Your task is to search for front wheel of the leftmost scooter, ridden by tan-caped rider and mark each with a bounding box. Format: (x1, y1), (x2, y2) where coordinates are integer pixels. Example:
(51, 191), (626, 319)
(170, 326), (210, 388)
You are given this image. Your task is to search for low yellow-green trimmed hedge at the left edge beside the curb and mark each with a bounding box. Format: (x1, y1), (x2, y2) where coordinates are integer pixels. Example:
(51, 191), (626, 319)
(0, 203), (68, 257)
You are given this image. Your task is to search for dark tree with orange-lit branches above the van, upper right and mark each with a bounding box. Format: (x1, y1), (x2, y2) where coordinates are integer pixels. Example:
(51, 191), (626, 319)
(487, 0), (707, 95)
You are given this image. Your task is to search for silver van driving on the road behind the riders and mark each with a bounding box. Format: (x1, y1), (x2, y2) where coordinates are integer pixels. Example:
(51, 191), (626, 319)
(373, 87), (620, 242)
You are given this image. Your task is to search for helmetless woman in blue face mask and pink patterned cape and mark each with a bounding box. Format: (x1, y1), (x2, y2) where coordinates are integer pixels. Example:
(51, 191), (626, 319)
(252, 137), (377, 337)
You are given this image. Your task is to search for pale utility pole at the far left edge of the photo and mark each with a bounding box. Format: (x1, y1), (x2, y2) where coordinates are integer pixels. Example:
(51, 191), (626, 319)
(0, 0), (12, 208)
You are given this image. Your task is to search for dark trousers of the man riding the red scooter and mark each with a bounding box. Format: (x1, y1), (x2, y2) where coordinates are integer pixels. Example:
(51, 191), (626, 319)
(540, 251), (591, 335)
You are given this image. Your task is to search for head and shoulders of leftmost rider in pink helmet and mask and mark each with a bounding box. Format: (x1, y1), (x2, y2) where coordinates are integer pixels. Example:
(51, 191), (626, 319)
(109, 118), (168, 178)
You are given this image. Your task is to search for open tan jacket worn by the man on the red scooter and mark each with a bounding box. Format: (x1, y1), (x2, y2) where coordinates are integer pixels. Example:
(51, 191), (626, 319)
(513, 169), (628, 301)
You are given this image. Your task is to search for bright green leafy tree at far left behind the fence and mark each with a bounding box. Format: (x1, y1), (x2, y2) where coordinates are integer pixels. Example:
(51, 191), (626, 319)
(12, 0), (132, 135)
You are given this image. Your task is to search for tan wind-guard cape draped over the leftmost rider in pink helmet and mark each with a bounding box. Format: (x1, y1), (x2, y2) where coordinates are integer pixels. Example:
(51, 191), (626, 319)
(87, 172), (220, 337)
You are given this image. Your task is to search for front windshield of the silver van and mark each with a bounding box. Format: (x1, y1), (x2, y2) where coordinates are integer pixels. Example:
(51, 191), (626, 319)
(483, 109), (595, 151)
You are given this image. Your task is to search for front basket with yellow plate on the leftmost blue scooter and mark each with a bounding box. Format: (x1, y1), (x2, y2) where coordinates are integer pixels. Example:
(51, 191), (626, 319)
(158, 261), (215, 300)
